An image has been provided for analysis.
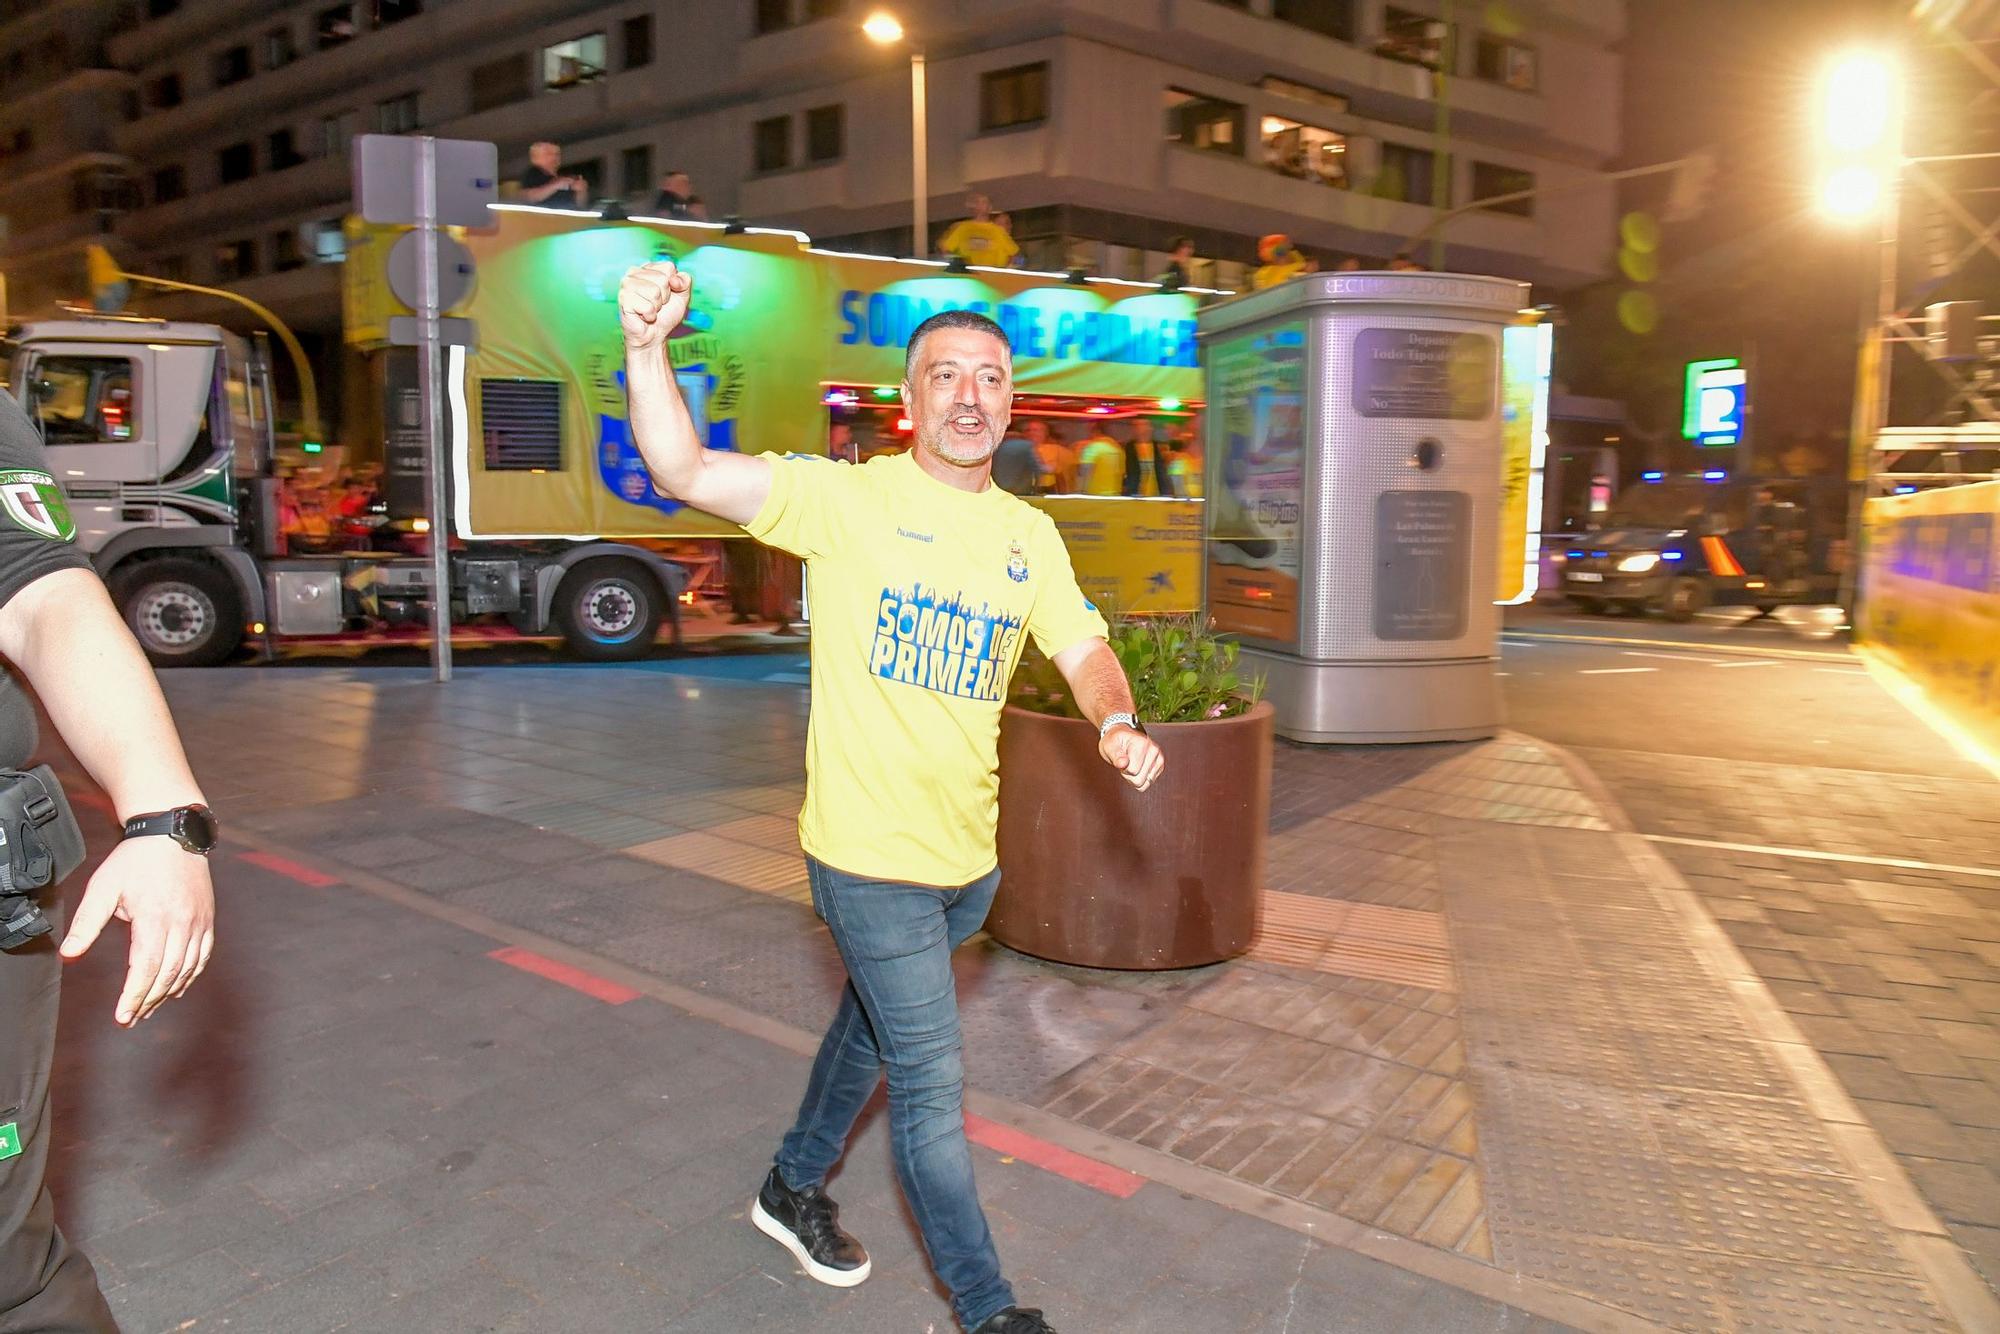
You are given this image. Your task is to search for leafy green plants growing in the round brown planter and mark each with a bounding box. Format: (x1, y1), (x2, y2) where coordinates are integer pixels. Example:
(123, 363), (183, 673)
(1008, 616), (1264, 722)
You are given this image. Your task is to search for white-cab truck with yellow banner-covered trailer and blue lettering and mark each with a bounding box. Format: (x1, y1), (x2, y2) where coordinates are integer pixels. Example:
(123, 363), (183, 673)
(8, 206), (1204, 666)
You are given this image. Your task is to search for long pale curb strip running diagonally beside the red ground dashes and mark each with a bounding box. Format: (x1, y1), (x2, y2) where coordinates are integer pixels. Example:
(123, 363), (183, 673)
(230, 830), (1670, 1334)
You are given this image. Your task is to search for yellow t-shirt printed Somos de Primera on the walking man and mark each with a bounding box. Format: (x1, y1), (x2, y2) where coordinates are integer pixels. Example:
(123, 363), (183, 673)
(746, 454), (1106, 886)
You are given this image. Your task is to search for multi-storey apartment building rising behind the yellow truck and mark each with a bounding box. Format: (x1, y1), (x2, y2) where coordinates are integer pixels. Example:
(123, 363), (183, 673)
(94, 0), (1624, 350)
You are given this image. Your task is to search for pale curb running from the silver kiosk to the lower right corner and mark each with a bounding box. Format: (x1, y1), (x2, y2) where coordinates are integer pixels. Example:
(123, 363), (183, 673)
(1512, 732), (2000, 1330)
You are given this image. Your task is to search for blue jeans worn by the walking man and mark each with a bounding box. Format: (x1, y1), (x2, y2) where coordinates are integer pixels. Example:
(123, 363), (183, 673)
(778, 858), (1014, 1330)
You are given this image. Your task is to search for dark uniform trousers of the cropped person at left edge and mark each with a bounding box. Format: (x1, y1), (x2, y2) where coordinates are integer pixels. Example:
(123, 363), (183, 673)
(0, 902), (118, 1334)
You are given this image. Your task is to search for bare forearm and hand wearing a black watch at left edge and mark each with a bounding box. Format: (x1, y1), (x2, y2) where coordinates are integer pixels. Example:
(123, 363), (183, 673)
(0, 570), (216, 1028)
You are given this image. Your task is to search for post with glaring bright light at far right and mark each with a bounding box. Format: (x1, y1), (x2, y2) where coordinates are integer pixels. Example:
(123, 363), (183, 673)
(1814, 52), (1904, 626)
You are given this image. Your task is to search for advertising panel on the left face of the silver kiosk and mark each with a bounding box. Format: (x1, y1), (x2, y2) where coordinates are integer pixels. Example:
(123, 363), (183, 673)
(1206, 320), (1306, 644)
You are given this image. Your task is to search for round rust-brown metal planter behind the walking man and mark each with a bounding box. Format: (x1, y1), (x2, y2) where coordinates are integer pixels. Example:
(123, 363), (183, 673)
(986, 700), (1272, 968)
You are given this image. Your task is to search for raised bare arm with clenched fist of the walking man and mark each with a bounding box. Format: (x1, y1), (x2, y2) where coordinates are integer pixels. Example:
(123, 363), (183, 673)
(618, 260), (770, 524)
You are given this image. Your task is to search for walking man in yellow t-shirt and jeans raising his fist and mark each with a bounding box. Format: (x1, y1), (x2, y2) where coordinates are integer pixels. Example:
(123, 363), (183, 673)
(618, 262), (1164, 1334)
